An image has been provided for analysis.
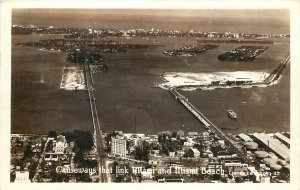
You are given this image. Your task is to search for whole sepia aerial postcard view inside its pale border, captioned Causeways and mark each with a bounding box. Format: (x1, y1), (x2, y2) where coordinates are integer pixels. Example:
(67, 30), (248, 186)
(1, 0), (299, 187)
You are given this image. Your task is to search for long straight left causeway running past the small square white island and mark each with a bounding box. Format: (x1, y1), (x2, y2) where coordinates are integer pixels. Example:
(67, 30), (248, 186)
(84, 62), (107, 182)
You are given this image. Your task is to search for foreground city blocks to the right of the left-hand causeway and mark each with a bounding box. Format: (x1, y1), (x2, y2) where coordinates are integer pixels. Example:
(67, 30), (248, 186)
(104, 130), (289, 183)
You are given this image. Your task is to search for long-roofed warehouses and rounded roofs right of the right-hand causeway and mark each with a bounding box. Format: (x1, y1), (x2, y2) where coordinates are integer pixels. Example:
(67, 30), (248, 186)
(231, 132), (290, 183)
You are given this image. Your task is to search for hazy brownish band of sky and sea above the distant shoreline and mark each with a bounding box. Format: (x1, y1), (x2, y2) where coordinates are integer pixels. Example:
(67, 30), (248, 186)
(12, 9), (290, 33)
